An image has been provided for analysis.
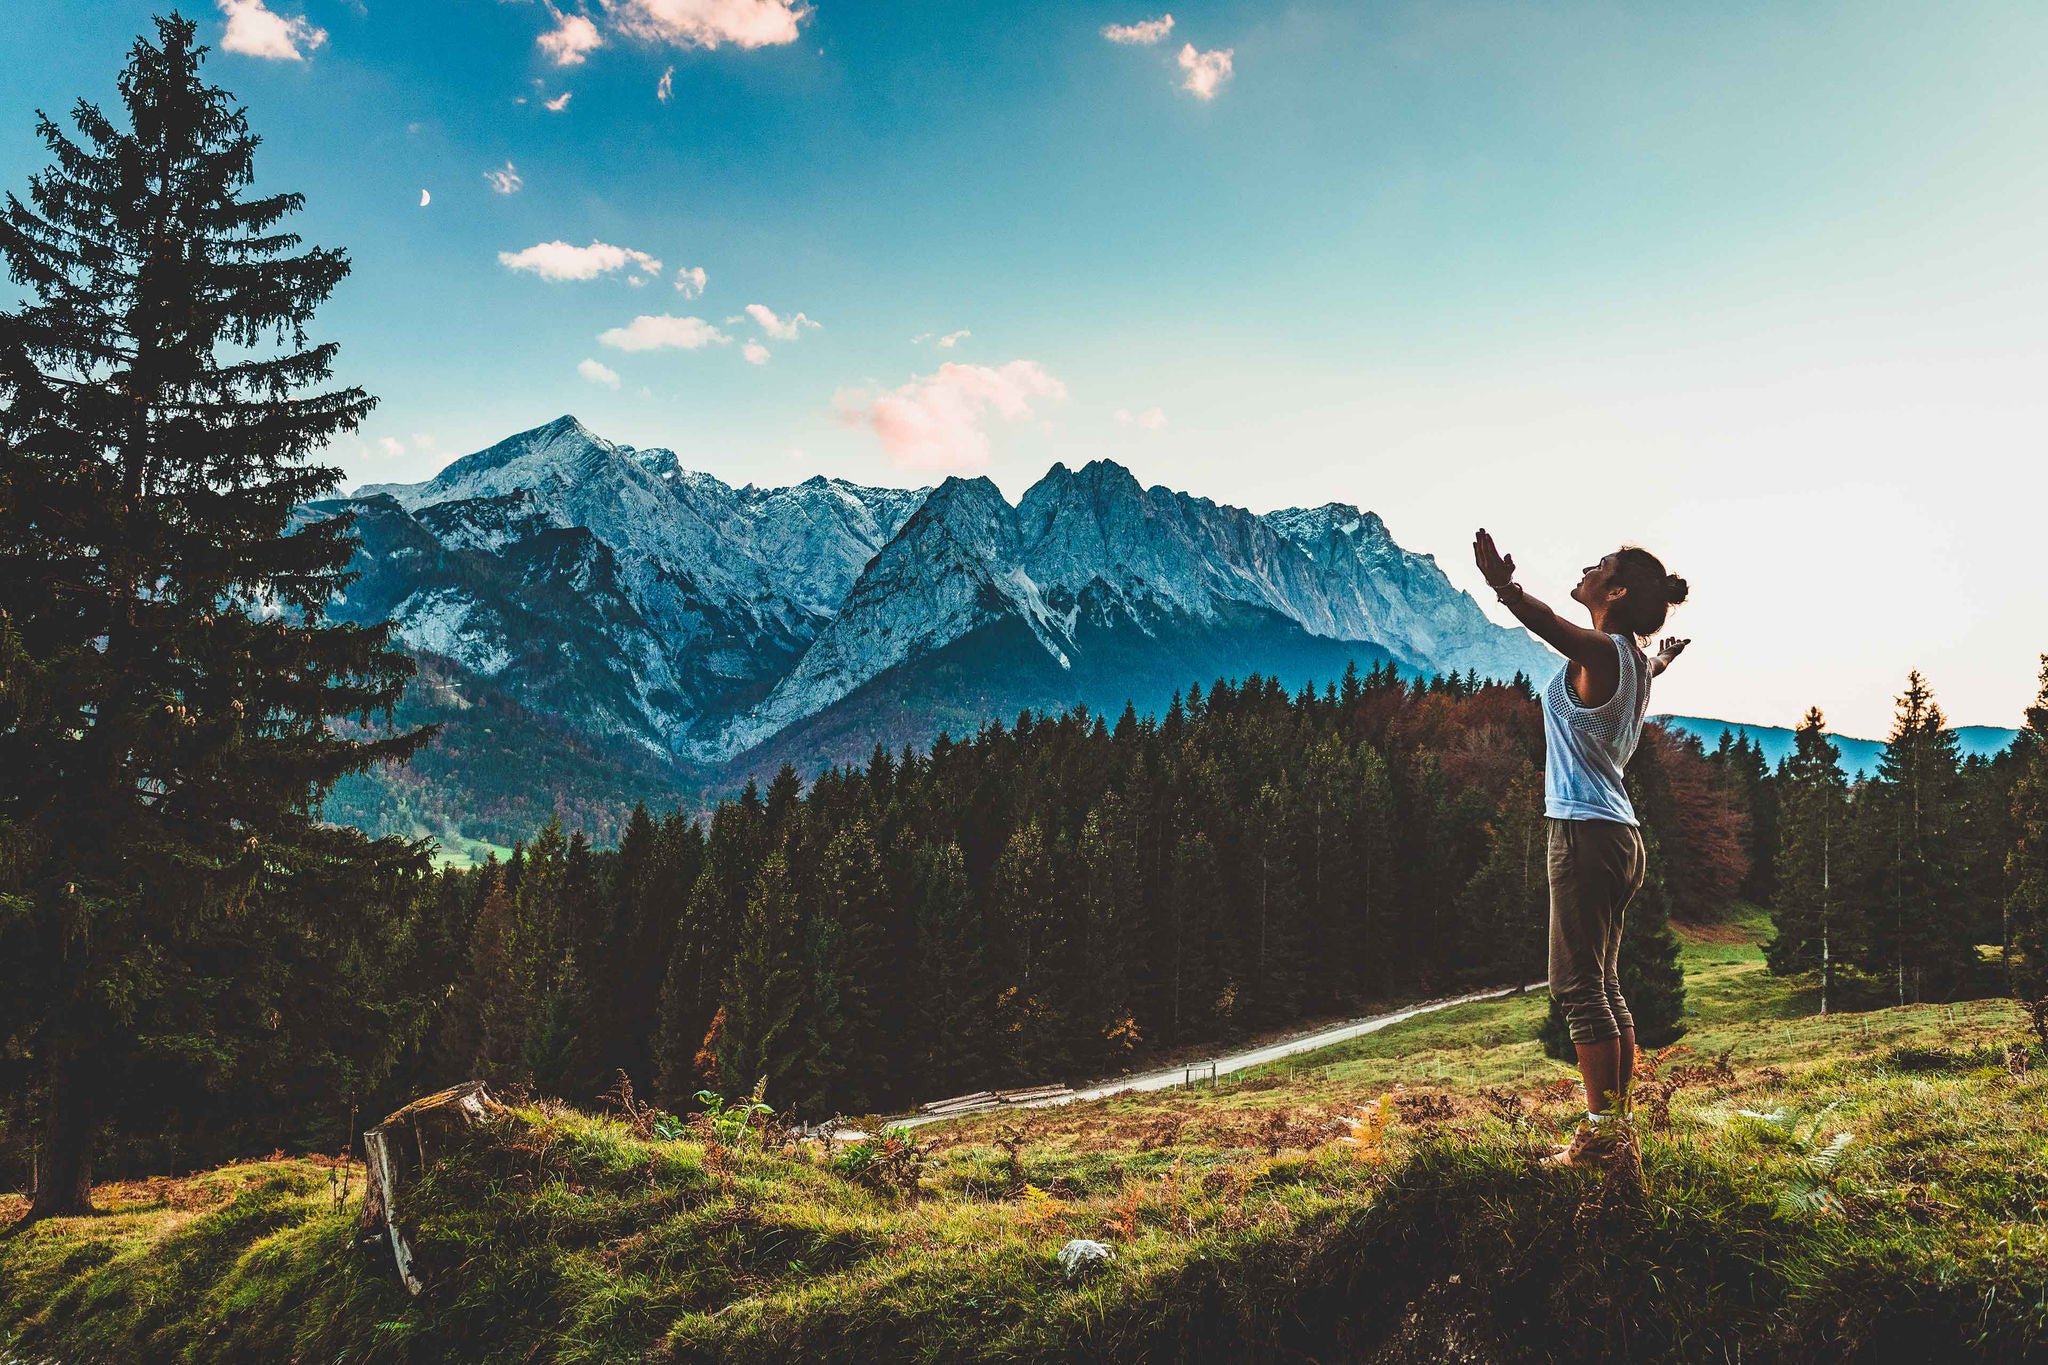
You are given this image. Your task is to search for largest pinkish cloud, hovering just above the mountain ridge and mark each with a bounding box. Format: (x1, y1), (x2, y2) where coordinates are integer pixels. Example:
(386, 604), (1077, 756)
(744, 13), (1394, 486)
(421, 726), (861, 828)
(834, 360), (1067, 471)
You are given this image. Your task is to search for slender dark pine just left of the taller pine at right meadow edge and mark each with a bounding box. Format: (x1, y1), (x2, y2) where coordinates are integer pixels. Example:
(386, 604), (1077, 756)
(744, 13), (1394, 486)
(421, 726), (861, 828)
(1763, 706), (1853, 1015)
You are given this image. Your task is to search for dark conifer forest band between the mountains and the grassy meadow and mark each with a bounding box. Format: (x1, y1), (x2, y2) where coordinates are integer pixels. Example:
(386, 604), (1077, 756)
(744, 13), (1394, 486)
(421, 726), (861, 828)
(376, 654), (2025, 1117)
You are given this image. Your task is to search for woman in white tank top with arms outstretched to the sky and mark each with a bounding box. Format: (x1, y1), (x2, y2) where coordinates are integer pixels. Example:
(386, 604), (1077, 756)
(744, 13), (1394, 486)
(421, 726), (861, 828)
(1473, 530), (1692, 1166)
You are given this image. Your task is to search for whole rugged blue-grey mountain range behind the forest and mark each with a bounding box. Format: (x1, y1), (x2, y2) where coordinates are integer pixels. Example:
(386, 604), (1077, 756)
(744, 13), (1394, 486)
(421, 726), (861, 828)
(303, 417), (1556, 837)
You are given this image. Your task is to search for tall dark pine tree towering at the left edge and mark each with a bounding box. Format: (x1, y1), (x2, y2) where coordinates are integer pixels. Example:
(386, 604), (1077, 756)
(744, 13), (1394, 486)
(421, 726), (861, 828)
(0, 16), (424, 1216)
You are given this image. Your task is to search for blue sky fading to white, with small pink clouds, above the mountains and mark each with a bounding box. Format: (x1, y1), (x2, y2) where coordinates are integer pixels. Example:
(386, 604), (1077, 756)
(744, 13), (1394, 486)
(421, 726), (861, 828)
(0, 0), (2048, 737)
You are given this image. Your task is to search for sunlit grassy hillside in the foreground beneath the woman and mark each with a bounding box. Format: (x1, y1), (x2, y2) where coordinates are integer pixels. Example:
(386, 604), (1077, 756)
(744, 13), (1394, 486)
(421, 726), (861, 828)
(0, 915), (2048, 1361)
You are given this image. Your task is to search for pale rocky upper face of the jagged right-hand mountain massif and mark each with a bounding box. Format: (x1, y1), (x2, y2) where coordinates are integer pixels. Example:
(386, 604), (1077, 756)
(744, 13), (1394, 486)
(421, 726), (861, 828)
(721, 460), (1548, 753)
